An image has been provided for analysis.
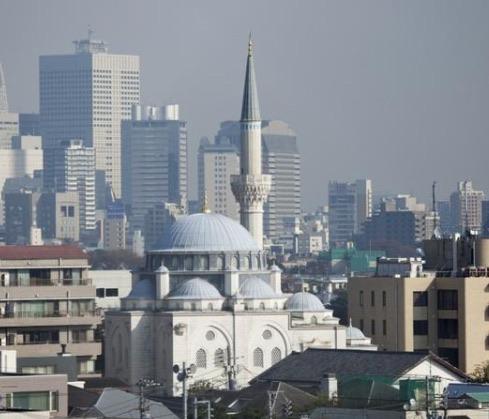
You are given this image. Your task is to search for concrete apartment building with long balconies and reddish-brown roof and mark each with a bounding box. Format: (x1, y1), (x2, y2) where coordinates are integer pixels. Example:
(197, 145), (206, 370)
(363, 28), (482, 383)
(0, 245), (101, 376)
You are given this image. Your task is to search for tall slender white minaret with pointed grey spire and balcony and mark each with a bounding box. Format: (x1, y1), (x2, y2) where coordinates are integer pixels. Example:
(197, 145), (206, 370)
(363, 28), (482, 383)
(231, 35), (271, 248)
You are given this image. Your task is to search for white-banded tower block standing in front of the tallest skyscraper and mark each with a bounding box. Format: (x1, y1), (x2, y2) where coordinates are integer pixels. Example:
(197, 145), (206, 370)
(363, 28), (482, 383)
(44, 139), (96, 235)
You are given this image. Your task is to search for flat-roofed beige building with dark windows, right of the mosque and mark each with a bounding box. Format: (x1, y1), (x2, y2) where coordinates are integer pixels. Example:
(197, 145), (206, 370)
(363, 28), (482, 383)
(348, 239), (489, 373)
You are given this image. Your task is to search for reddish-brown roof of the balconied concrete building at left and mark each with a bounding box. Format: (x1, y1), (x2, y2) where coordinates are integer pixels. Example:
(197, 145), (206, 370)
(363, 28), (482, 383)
(0, 245), (87, 260)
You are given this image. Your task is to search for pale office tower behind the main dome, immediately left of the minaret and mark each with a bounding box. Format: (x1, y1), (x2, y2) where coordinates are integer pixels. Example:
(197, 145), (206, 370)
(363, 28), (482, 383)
(198, 138), (239, 220)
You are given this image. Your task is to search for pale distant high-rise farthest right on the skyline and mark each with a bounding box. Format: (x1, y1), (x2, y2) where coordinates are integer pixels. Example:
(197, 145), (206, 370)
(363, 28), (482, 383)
(450, 180), (484, 233)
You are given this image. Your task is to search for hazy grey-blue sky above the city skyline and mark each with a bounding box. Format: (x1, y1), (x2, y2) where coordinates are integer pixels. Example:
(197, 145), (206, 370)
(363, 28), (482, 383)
(0, 0), (489, 208)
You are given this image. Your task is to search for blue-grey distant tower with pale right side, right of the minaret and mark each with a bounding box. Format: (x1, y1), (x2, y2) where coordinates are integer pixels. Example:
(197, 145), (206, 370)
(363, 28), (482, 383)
(328, 179), (372, 245)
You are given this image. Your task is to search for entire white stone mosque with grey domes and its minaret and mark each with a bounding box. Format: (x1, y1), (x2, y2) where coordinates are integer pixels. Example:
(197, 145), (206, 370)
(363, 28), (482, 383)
(105, 37), (377, 395)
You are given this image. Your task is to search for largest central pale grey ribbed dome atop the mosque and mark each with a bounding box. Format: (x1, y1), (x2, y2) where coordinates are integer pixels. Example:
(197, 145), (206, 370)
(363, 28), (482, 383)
(158, 213), (260, 252)
